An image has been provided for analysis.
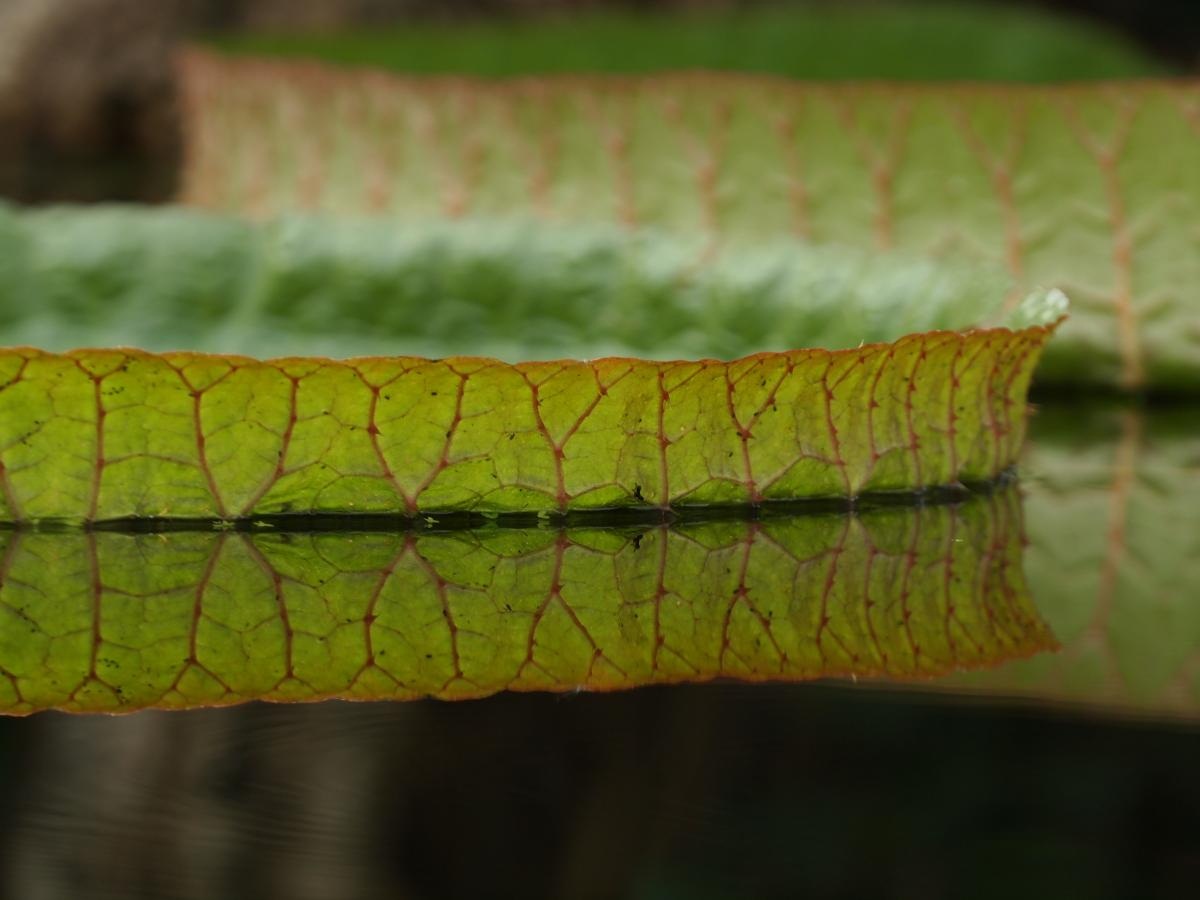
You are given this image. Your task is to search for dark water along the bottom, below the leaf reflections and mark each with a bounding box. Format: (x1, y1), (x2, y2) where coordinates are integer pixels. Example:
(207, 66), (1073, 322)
(0, 684), (1200, 898)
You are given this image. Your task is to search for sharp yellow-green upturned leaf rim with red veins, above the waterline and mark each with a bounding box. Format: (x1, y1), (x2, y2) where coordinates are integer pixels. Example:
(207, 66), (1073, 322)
(0, 325), (1055, 523)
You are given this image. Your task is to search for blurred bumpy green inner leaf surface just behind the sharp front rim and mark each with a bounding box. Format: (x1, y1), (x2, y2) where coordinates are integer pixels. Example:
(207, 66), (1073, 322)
(0, 206), (1032, 362)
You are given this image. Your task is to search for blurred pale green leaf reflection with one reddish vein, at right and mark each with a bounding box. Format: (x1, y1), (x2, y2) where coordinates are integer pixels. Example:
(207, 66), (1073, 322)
(945, 407), (1200, 716)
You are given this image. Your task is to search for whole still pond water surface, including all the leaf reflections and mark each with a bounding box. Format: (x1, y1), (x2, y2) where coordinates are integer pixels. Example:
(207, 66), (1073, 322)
(0, 404), (1200, 898)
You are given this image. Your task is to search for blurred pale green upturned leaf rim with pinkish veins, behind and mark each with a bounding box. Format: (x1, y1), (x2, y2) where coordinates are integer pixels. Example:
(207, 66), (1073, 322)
(182, 53), (1200, 389)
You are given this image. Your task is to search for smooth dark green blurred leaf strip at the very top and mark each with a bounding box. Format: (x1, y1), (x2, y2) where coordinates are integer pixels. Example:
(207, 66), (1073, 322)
(214, 2), (1162, 82)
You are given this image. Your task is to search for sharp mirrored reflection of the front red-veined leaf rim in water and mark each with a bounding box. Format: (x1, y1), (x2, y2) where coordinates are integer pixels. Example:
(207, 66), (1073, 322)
(0, 488), (1052, 713)
